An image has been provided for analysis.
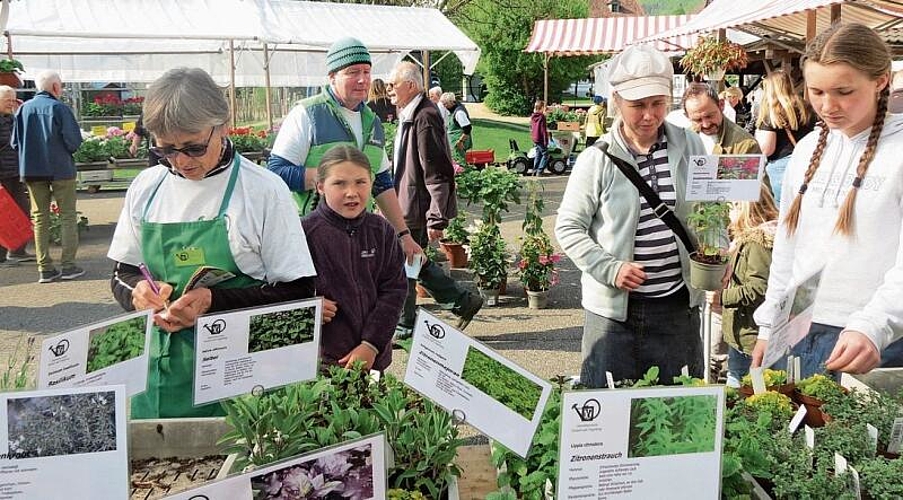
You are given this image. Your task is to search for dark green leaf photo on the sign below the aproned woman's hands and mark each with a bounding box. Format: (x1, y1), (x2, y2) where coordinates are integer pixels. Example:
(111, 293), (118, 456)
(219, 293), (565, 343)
(248, 305), (316, 353)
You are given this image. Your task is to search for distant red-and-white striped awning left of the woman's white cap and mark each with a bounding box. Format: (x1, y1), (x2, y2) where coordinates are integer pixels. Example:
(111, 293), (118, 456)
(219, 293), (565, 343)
(525, 15), (697, 56)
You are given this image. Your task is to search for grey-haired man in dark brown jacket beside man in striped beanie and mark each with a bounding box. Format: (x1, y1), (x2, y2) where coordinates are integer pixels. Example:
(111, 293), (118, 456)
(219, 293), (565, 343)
(387, 62), (483, 338)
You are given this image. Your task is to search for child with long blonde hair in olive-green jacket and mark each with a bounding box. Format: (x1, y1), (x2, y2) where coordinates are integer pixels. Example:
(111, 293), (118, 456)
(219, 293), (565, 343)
(711, 184), (778, 387)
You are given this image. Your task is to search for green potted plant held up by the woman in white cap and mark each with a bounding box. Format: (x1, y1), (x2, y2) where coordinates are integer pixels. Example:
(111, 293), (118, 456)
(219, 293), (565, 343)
(687, 202), (730, 291)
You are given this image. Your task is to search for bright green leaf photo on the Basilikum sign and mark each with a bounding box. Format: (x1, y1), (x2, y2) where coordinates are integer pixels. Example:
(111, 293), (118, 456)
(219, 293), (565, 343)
(86, 316), (147, 373)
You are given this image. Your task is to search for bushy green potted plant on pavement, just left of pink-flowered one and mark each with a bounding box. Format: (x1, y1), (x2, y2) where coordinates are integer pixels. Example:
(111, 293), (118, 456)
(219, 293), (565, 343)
(467, 221), (508, 306)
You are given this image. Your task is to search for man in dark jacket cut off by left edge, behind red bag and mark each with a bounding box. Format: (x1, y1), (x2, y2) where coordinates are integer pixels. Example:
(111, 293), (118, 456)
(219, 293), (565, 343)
(0, 85), (35, 267)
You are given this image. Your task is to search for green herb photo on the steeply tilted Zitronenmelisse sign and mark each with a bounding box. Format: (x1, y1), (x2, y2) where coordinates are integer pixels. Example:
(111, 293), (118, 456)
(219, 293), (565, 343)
(461, 346), (542, 420)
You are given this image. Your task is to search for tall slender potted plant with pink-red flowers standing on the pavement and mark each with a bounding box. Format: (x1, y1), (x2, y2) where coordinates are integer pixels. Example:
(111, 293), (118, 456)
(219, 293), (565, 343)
(517, 182), (561, 309)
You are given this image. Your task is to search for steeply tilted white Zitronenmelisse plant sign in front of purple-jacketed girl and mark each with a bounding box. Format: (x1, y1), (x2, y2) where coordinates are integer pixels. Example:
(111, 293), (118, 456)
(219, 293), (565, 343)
(404, 309), (552, 457)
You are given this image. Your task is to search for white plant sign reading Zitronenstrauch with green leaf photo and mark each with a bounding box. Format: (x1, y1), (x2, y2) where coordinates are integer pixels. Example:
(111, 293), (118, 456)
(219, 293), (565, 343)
(556, 386), (724, 500)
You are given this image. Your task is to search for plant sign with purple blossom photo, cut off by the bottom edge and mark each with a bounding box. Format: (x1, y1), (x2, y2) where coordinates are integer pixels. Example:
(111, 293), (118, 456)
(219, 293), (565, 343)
(166, 434), (387, 500)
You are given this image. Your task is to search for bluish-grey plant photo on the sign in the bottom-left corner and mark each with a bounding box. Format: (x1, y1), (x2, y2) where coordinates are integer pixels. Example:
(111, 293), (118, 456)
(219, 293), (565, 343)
(6, 391), (116, 458)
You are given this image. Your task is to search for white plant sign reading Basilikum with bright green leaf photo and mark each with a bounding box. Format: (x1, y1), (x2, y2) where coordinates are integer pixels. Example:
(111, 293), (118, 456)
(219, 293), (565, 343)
(38, 310), (154, 396)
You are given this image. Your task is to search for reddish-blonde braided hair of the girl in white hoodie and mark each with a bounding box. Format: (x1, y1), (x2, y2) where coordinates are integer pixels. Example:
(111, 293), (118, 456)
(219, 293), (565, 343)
(784, 24), (891, 236)
